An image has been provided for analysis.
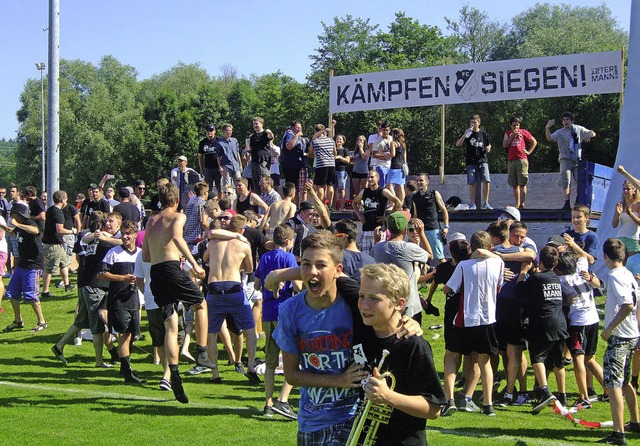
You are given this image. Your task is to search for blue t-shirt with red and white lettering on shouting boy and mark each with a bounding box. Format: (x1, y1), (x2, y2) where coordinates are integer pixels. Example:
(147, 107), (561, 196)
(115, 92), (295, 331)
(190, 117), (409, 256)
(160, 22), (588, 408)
(273, 291), (358, 432)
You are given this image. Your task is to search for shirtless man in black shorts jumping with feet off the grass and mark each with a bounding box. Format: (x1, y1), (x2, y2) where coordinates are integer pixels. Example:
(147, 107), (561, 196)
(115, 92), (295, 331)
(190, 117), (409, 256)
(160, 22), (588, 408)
(142, 184), (213, 404)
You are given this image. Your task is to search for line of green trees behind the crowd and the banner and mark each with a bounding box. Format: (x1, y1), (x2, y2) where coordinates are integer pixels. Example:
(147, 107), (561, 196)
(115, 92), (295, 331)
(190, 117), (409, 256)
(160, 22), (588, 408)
(11, 3), (628, 195)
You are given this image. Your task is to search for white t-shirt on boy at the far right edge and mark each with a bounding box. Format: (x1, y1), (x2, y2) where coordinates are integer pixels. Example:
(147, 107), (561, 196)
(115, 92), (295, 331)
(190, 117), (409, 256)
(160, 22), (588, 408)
(604, 266), (640, 339)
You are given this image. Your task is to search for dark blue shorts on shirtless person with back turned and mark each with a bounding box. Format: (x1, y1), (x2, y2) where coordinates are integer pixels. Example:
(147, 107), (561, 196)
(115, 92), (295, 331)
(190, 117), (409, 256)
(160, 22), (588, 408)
(207, 281), (256, 333)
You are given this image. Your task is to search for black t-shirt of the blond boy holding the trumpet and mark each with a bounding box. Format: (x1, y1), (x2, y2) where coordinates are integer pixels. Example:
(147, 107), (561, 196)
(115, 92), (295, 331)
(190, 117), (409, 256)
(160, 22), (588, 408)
(353, 327), (446, 446)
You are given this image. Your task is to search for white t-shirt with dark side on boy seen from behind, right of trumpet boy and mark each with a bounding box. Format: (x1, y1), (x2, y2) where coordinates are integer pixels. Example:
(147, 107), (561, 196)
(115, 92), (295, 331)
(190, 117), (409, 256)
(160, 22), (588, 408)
(447, 257), (504, 327)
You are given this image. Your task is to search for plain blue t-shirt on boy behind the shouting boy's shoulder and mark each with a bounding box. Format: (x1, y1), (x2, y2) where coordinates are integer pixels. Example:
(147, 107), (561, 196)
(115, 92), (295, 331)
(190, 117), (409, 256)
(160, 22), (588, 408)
(255, 248), (298, 322)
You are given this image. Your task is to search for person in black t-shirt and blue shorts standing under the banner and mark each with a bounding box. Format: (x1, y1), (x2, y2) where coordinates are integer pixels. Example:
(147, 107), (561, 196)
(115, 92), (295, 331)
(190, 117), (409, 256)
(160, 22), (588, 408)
(456, 115), (493, 210)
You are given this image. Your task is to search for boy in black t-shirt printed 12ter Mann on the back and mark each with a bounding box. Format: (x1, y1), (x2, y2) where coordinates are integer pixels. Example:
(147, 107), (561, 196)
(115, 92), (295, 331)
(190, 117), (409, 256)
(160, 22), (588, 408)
(516, 246), (569, 415)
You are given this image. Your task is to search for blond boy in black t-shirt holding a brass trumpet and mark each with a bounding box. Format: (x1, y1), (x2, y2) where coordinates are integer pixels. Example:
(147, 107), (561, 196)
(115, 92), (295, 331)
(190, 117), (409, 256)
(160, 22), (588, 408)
(352, 263), (445, 446)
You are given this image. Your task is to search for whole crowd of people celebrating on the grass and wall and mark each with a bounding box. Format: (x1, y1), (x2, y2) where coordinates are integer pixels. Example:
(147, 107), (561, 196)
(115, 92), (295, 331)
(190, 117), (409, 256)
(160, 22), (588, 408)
(0, 115), (640, 445)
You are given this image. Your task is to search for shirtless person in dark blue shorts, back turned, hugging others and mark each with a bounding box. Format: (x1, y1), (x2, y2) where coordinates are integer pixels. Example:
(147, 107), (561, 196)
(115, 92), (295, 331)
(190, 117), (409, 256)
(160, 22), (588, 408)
(203, 215), (260, 384)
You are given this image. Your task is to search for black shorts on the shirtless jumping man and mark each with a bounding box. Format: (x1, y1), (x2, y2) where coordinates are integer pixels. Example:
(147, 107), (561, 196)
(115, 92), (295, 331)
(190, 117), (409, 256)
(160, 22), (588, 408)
(150, 260), (204, 319)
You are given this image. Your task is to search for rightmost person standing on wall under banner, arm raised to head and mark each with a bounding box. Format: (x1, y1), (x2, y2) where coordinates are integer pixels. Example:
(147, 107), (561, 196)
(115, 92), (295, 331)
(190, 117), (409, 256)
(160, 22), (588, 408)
(544, 112), (596, 210)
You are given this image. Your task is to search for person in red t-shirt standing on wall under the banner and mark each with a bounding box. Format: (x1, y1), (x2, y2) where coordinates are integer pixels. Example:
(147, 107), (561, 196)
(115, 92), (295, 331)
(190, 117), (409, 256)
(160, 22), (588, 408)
(502, 116), (538, 209)
